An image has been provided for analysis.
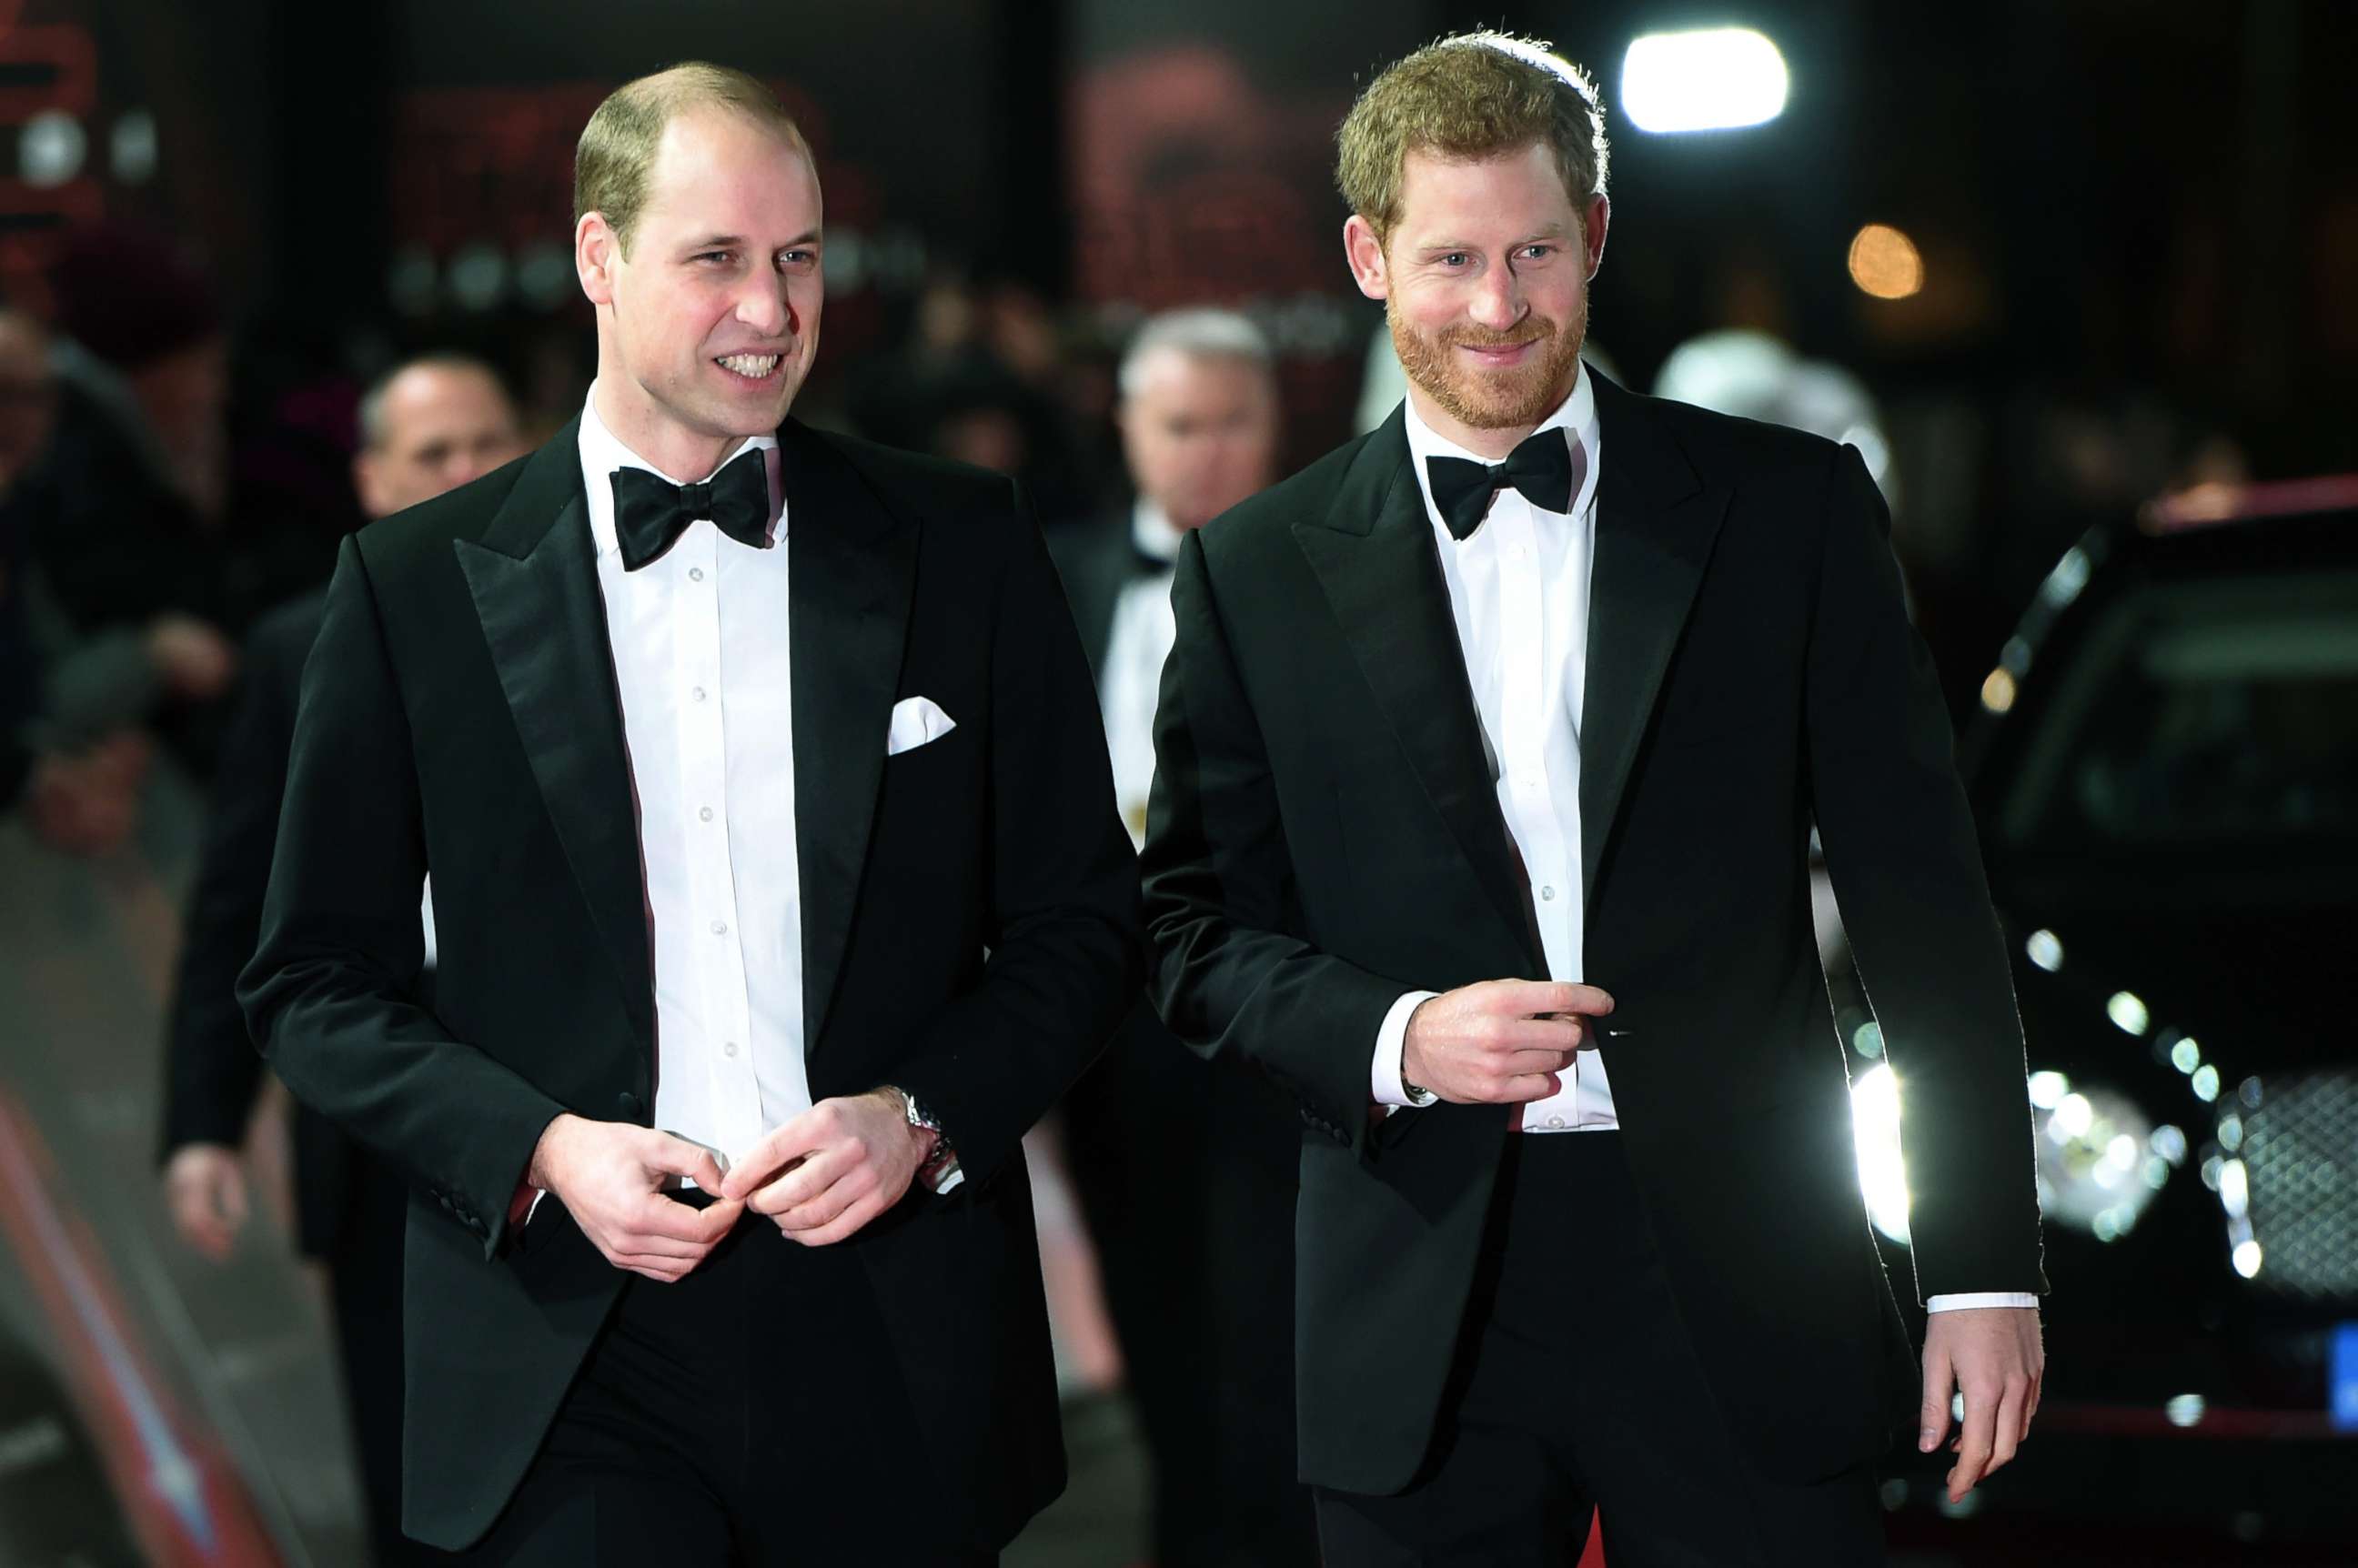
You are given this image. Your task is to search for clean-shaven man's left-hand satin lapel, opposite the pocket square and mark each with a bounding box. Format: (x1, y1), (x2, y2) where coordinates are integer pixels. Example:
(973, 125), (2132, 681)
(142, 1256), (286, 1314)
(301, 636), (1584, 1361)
(453, 419), (656, 1047)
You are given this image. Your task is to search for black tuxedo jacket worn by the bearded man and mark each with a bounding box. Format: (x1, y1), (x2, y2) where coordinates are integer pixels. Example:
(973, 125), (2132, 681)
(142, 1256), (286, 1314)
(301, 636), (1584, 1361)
(1144, 373), (2042, 1493)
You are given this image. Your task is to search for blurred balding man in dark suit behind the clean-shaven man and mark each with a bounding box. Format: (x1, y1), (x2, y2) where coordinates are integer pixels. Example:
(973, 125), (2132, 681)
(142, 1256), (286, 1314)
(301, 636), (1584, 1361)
(163, 354), (523, 1563)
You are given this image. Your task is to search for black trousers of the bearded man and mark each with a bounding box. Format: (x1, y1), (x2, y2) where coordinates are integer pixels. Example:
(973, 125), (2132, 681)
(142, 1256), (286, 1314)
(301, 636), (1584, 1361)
(1318, 1131), (1884, 1568)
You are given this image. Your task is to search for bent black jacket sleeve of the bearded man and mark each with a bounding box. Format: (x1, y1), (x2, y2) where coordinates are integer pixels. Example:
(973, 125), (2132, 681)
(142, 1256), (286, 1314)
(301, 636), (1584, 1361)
(1144, 535), (1410, 1153)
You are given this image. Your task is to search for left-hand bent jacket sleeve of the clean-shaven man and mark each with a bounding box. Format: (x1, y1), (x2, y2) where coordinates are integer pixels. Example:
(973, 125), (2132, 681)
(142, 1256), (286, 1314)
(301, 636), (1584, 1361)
(238, 538), (563, 1257)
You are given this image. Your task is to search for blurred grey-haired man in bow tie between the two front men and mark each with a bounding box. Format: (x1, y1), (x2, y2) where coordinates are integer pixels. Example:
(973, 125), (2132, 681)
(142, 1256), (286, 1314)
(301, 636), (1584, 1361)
(1056, 309), (1318, 1568)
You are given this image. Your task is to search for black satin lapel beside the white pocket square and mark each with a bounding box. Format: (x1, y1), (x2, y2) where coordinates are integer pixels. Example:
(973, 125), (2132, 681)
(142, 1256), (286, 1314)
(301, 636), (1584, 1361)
(778, 419), (917, 1051)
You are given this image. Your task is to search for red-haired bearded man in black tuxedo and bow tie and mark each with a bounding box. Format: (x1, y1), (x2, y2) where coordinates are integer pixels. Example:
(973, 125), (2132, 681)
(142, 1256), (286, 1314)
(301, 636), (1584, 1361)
(1146, 33), (2044, 1568)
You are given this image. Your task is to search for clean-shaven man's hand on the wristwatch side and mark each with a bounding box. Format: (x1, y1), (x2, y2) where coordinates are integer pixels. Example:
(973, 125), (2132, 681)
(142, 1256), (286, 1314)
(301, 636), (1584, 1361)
(721, 1090), (933, 1247)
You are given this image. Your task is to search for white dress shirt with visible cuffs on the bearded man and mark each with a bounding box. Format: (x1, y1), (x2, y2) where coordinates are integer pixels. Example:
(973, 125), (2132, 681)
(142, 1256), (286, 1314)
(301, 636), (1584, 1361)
(1370, 367), (2037, 1311)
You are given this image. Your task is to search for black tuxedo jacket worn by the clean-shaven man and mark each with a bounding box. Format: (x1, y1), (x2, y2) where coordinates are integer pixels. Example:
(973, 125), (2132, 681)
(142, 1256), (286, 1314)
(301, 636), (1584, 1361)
(240, 410), (1142, 1549)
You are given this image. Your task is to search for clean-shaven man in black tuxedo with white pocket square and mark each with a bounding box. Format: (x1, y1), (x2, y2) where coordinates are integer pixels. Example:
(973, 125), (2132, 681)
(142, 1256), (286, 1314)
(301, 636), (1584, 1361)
(240, 64), (1142, 1565)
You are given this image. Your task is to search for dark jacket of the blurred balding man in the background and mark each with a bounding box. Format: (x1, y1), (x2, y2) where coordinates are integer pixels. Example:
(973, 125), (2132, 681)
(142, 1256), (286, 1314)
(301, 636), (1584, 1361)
(163, 592), (351, 1257)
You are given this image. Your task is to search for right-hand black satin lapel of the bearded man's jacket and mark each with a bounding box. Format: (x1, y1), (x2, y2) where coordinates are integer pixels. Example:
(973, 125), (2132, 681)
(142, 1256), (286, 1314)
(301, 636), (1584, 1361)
(1580, 370), (1728, 900)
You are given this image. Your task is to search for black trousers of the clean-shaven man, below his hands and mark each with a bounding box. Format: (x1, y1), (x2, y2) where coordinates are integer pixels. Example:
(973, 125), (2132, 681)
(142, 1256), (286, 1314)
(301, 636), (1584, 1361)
(459, 1214), (997, 1568)
